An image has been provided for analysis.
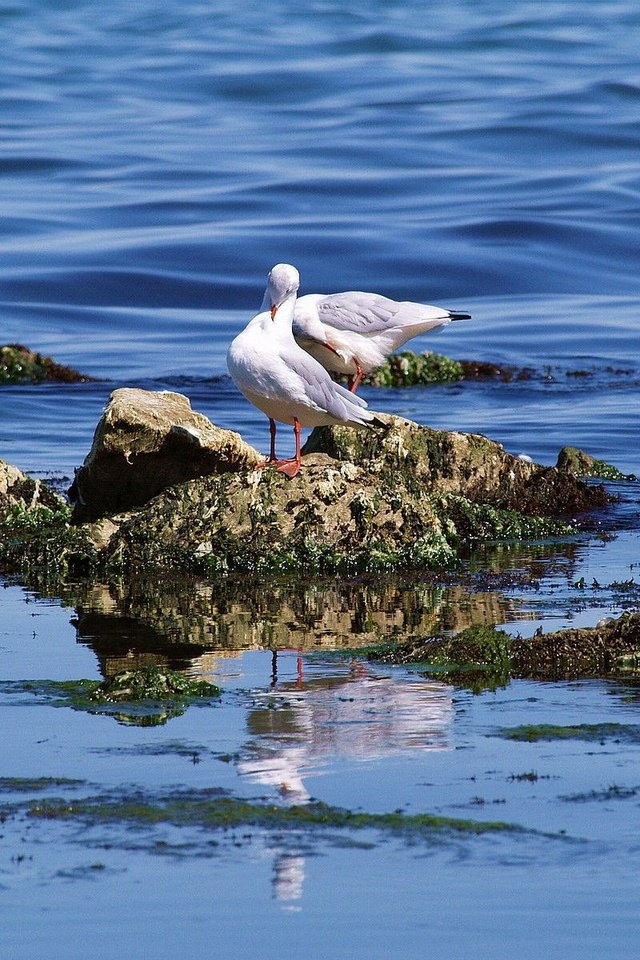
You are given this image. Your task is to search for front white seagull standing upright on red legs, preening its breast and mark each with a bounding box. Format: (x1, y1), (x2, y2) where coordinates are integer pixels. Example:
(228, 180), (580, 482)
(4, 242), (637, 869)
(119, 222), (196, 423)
(227, 263), (376, 478)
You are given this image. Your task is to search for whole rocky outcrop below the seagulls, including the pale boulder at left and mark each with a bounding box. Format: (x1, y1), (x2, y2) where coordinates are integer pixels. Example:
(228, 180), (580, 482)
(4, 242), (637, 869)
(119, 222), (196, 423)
(0, 400), (610, 577)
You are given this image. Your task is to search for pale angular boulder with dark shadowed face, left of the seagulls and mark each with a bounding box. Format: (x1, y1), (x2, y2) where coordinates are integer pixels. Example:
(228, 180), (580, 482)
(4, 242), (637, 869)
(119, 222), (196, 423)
(69, 388), (262, 522)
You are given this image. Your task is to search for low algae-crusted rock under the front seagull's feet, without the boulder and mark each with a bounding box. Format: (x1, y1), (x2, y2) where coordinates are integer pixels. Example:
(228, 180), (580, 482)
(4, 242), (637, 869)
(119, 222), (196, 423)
(89, 417), (608, 574)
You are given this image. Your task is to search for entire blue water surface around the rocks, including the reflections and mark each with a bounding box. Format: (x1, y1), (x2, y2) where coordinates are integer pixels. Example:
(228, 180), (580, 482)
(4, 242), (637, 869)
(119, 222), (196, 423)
(0, 0), (640, 960)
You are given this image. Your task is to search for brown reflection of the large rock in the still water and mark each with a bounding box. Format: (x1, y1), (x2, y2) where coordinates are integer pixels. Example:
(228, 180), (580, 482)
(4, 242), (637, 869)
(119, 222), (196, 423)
(67, 580), (517, 675)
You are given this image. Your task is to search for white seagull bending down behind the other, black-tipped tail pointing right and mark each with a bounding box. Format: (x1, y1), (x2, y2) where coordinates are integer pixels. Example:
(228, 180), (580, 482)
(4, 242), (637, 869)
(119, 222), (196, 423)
(288, 288), (470, 393)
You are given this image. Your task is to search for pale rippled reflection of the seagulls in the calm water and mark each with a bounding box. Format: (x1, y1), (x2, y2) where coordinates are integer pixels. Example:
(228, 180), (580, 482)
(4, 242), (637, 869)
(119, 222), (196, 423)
(238, 660), (453, 803)
